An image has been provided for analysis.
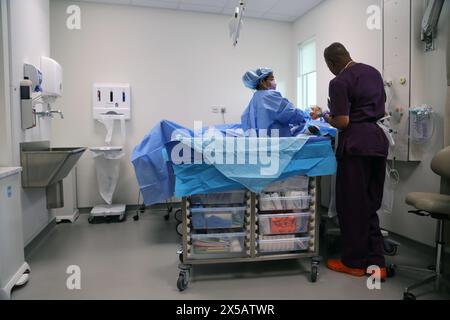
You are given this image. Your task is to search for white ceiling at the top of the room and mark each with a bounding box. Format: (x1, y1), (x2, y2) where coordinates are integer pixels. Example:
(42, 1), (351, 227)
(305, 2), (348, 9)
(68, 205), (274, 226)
(76, 0), (323, 22)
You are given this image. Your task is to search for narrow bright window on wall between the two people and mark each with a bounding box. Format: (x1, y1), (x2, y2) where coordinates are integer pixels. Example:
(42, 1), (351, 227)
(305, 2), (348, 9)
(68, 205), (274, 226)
(297, 39), (317, 109)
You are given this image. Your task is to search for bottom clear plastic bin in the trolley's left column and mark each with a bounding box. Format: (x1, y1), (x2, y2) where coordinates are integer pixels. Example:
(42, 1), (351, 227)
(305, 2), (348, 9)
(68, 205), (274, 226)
(191, 232), (245, 256)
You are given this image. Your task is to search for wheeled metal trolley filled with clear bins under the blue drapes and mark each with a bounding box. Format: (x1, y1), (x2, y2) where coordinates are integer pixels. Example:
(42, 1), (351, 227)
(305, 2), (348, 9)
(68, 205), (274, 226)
(177, 177), (320, 291)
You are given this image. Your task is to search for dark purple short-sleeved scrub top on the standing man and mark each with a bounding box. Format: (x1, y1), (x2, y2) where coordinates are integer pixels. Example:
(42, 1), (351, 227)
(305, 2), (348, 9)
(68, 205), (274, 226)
(328, 63), (389, 158)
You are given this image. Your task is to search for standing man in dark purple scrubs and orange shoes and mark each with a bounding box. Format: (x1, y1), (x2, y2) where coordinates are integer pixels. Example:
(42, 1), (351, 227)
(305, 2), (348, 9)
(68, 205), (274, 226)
(324, 43), (389, 280)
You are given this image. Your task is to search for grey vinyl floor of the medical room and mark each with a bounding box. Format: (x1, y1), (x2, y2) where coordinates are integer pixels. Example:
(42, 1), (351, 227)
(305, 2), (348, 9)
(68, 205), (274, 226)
(12, 211), (450, 300)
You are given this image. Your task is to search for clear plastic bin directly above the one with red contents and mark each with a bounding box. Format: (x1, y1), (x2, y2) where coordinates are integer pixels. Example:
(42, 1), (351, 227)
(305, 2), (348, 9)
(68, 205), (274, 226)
(259, 195), (311, 211)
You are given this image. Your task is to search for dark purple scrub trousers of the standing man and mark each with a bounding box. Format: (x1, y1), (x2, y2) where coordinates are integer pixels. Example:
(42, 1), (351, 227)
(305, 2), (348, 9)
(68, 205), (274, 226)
(336, 156), (386, 269)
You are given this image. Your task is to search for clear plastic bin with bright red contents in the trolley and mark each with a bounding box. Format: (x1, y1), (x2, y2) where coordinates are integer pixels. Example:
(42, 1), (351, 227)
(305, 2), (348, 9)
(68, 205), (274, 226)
(259, 212), (311, 235)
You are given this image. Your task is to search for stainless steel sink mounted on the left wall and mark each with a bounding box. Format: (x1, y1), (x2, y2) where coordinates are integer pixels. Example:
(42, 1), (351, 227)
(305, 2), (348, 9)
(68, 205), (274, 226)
(20, 141), (86, 209)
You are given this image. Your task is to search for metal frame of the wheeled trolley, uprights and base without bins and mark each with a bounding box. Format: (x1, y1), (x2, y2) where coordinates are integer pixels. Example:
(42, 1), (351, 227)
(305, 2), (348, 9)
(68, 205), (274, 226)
(177, 177), (321, 291)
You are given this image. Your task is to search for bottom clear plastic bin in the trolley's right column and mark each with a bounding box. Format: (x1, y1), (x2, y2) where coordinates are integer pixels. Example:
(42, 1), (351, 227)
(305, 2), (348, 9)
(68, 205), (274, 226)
(258, 236), (311, 253)
